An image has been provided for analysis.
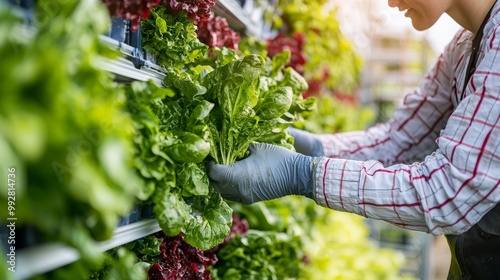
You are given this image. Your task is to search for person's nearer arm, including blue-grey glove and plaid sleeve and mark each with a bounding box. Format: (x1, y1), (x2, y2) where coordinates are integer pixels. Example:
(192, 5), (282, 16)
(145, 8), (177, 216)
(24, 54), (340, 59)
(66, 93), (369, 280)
(209, 30), (500, 234)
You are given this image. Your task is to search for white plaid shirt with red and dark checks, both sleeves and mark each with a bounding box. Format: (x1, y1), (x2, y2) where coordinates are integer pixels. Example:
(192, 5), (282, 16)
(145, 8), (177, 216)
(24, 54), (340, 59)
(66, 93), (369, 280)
(313, 2), (500, 235)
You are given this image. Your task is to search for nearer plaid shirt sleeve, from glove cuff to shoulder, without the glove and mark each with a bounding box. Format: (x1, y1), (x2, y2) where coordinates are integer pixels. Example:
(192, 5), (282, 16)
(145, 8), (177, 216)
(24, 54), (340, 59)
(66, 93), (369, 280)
(314, 29), (500, 234)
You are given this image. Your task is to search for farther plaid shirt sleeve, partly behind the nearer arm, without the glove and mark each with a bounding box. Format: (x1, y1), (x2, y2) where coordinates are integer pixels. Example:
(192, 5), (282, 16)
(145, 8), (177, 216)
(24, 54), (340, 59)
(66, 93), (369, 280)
(312, 30), (480, 165)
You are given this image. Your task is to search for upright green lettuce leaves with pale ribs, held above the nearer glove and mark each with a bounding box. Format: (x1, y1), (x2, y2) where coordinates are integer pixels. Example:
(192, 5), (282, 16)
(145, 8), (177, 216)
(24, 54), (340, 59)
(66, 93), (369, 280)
(202, 55), (278, 164)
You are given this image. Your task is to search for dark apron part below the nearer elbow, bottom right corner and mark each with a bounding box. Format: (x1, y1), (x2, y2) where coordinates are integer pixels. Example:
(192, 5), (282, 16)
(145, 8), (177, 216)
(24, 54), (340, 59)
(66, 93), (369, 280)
(446, 203), (500, 280)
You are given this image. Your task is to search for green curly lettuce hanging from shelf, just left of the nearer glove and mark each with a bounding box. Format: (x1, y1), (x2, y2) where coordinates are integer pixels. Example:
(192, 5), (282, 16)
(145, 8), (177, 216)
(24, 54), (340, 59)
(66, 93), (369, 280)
(127, 80), (232, 250)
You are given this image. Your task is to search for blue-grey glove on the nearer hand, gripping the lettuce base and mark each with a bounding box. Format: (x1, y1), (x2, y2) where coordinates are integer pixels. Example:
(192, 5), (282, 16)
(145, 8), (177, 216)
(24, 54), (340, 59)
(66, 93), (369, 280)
(208, 143), (314, 204)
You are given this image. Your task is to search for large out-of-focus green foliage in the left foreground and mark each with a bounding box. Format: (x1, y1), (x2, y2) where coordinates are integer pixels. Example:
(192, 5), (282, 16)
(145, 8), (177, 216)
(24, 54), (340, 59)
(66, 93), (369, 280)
(0, 0), (140, 261)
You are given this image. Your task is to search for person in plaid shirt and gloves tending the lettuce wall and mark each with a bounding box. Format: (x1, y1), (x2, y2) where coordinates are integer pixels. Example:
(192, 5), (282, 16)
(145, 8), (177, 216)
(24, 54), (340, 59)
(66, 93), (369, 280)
(208, 0), (500, 279)
